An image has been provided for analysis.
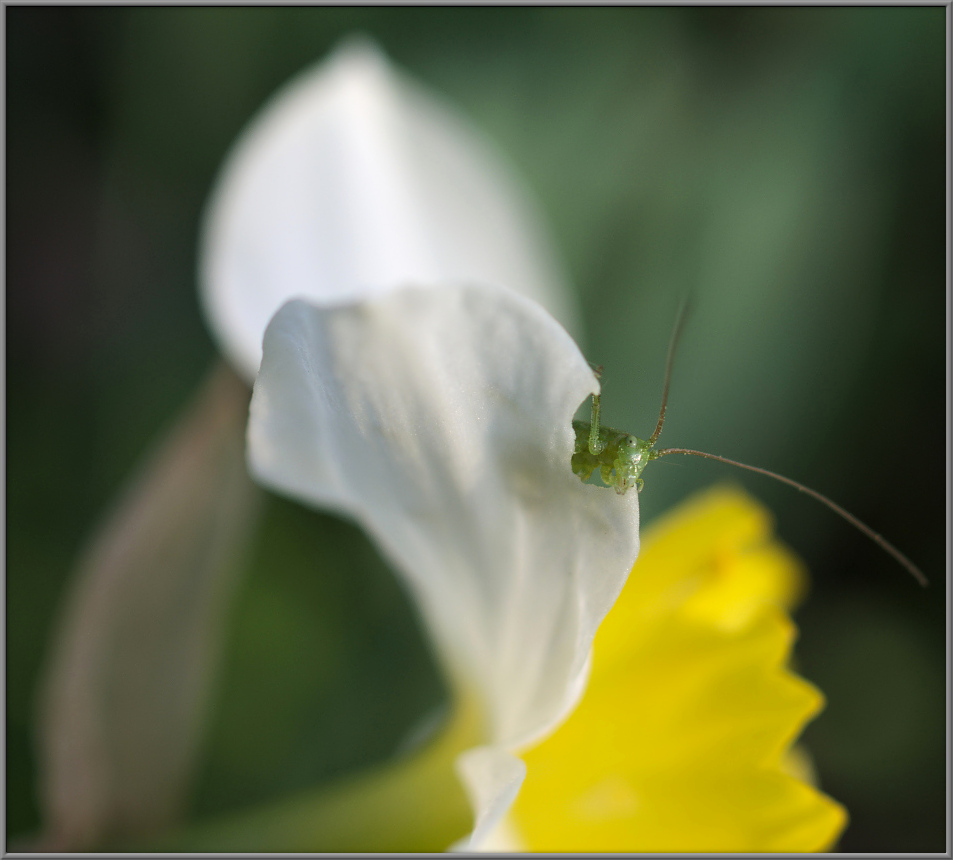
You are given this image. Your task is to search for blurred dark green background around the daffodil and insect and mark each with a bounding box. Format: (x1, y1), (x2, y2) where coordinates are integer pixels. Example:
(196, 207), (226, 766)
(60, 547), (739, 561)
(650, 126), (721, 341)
(4, 7), (948, 852)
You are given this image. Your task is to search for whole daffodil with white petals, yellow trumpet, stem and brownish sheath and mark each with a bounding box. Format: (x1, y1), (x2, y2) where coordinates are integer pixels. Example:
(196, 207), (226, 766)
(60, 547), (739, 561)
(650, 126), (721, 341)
(27, 30), (844, 851)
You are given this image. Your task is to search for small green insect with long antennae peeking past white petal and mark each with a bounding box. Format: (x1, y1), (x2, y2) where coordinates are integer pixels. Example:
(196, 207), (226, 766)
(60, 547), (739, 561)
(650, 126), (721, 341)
(572, 305), (927, 586)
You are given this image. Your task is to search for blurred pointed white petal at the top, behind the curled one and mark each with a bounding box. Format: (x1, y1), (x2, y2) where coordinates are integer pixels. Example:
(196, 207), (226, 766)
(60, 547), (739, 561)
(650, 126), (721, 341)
(199, 40), (575, 379)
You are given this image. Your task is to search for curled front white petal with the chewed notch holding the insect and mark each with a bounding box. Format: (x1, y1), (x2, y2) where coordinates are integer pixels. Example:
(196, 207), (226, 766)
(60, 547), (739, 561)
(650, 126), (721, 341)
(248, 286), (638, 840)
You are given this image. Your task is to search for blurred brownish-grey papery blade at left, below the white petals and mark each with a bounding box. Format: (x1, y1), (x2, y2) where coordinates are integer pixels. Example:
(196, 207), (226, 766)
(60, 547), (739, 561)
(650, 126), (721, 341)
(33, 365), (258, 851)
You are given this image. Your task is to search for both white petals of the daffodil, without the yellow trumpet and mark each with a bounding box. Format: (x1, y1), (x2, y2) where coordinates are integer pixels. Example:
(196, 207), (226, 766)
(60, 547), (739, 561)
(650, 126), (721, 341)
(202, 38), (639, 847)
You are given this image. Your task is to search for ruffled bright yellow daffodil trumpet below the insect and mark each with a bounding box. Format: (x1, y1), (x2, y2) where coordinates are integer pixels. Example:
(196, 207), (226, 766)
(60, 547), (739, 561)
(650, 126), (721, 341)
(512, 489), (846, 852)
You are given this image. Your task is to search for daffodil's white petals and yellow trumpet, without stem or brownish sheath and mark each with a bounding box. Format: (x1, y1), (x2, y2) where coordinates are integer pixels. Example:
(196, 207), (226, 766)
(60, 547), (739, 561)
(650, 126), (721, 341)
(202, 37), (843, 851)
